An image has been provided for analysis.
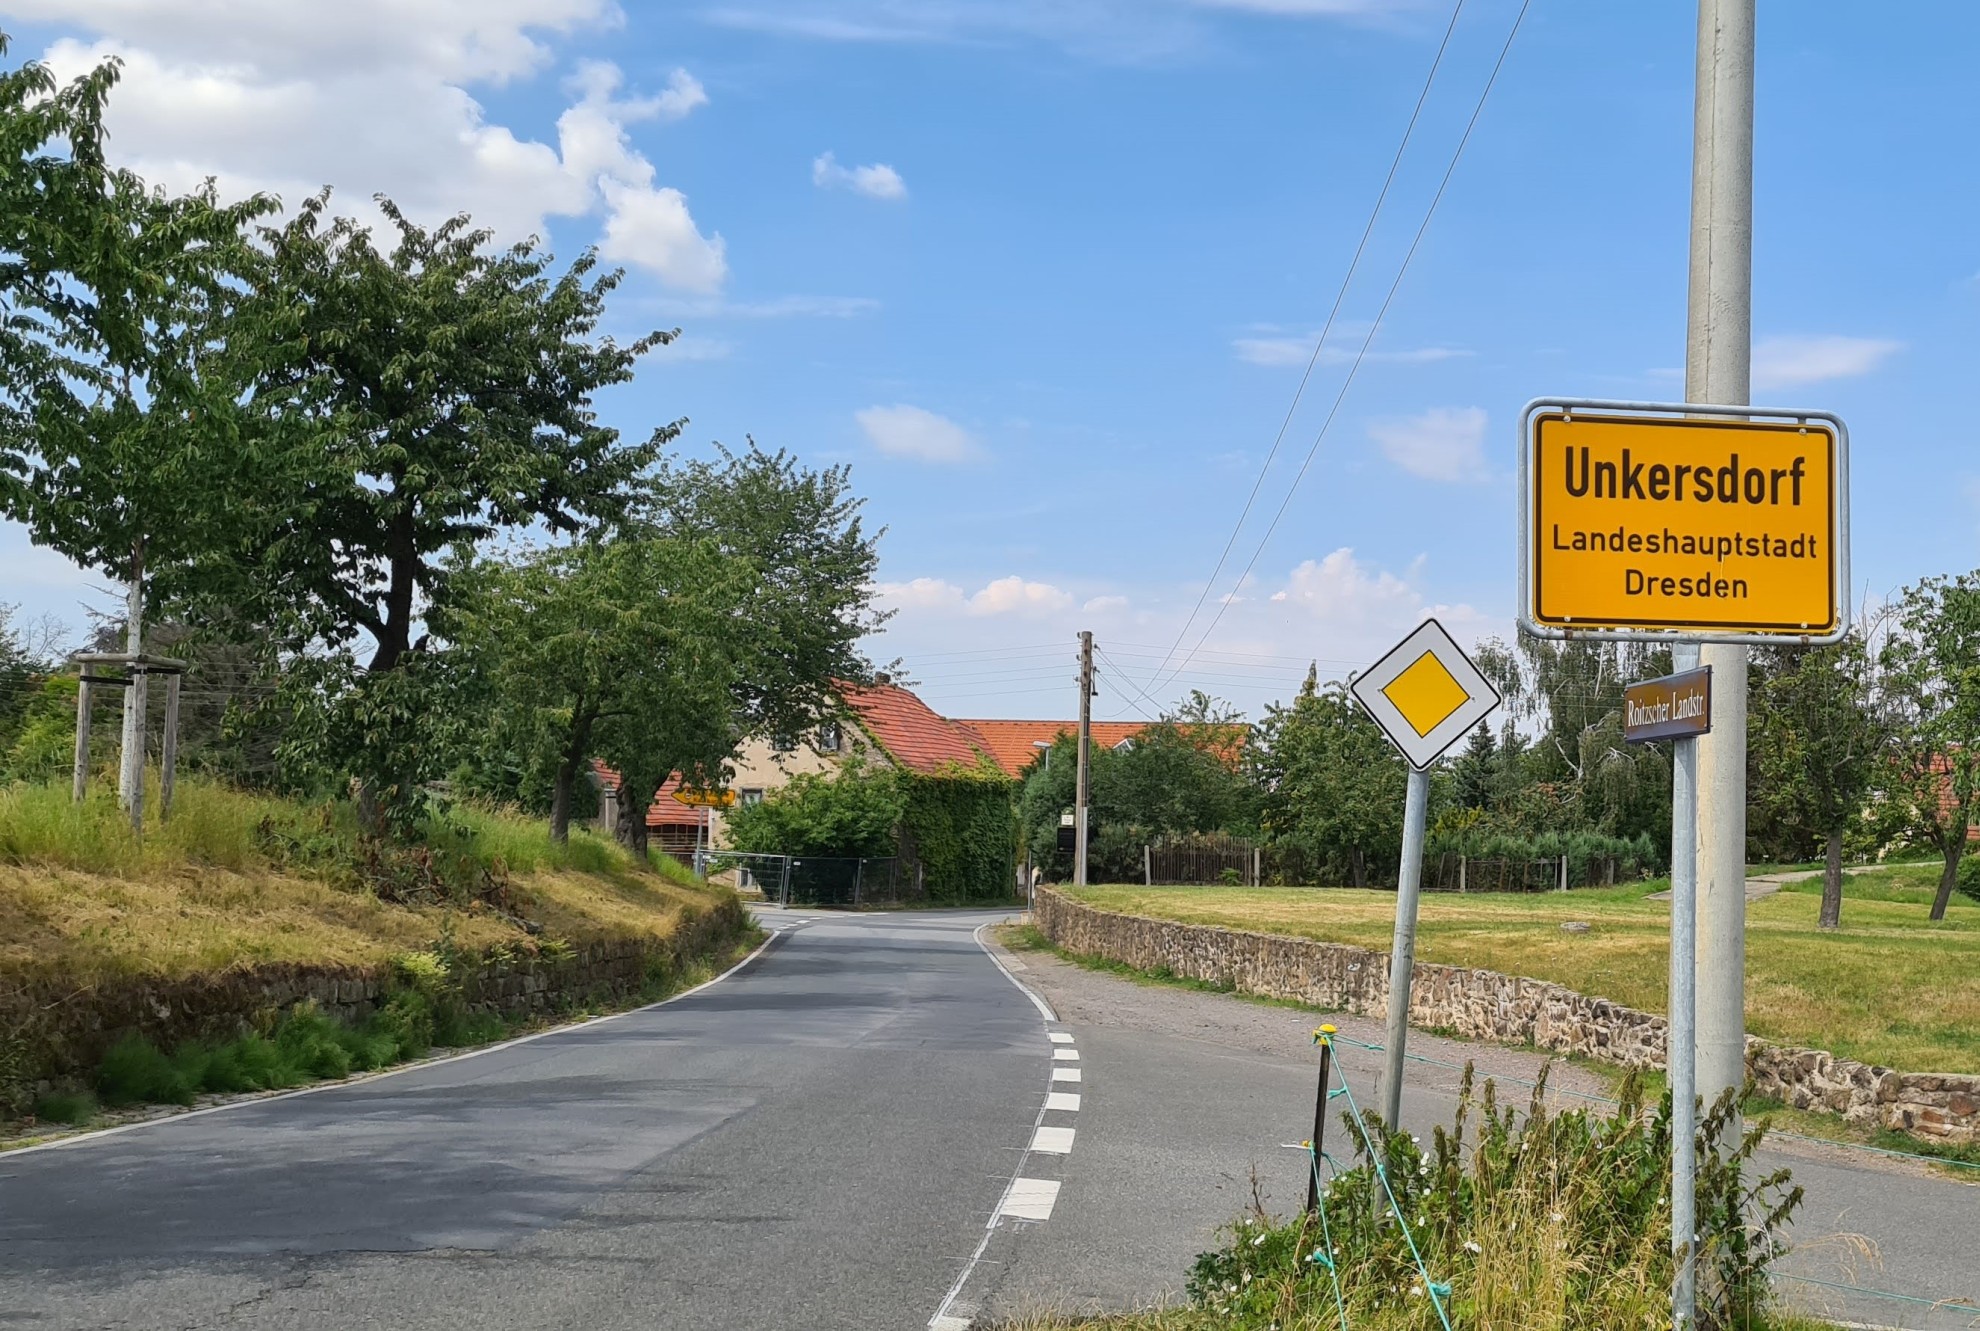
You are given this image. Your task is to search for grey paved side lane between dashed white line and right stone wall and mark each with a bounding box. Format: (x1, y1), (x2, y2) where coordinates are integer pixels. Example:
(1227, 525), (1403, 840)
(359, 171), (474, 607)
(990, 934), (1980, 1331)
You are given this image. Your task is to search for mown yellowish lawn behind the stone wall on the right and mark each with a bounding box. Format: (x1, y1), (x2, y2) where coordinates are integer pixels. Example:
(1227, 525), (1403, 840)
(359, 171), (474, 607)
(1067, 864), (1980, 1072)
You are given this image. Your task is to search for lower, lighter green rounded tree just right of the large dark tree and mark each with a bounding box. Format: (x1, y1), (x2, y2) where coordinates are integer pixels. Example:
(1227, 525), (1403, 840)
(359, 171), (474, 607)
(451, 535), (748, 842)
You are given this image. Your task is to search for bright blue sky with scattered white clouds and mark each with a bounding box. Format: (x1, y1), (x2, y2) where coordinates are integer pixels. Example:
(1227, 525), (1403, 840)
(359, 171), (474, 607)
(0, 0), (1980, 717)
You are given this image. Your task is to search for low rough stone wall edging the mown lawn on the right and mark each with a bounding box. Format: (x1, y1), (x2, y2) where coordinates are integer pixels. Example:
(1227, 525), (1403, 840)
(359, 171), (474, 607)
(1038, 887), (1980, 1141)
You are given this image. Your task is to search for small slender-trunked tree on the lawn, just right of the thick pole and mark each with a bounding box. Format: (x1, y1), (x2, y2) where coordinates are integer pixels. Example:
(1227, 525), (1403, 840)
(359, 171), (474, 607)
(1748, 634), (1889, 929)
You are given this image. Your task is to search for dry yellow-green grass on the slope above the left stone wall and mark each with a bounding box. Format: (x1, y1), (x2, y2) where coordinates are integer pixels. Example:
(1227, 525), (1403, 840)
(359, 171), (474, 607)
(0, 778), (723, 986)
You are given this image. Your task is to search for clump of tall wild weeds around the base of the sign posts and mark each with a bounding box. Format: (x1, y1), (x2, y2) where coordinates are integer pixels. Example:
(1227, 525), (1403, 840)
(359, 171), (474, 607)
(1030, 1072), (1804, 1331)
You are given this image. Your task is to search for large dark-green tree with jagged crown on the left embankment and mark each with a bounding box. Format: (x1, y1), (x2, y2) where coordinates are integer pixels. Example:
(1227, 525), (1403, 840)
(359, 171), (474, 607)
(232, 194), (677, 832)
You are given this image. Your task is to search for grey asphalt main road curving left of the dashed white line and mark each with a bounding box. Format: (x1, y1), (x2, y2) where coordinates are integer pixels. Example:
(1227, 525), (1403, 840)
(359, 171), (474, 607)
(0, 913), (1063, 1331)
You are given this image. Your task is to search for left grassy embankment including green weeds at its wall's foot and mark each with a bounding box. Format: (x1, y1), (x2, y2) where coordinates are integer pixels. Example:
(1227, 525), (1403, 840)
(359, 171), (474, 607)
(0, 778), (748, 1123)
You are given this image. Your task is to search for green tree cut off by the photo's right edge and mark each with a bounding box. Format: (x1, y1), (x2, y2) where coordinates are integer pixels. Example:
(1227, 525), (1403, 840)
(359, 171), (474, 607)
(1879, 572), (1980, 919)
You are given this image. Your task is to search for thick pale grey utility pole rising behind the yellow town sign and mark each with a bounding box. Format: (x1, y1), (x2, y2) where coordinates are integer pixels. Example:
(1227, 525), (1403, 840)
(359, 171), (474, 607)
(1685, 0), (1754, 1140)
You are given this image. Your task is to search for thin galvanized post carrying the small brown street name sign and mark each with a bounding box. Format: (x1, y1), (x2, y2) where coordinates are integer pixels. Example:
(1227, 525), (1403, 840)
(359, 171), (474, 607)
(1663, 642), (1699, 1331)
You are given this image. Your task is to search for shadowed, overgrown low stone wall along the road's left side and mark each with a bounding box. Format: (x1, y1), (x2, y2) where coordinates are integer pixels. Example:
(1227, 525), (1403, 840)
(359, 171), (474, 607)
(0, 897), (748, 1079)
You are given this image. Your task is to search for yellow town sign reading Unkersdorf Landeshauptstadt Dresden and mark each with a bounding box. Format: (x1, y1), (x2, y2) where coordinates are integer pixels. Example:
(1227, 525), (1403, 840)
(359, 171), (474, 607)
(1521, 398), (1849, 644)
